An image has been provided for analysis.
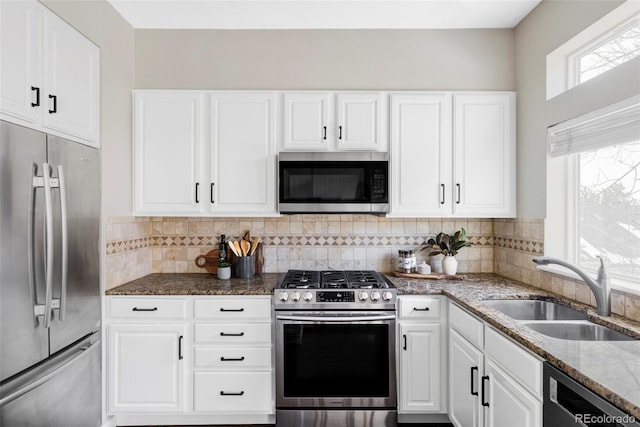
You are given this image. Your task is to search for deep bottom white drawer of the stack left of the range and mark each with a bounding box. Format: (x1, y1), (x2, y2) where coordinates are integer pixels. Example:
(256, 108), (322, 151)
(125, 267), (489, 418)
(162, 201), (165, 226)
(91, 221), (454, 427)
(193, 372), (273, 414)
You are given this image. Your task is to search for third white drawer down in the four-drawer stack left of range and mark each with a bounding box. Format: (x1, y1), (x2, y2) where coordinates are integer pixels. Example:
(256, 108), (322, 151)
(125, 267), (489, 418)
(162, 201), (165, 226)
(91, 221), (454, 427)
(193, 347), (271, 369)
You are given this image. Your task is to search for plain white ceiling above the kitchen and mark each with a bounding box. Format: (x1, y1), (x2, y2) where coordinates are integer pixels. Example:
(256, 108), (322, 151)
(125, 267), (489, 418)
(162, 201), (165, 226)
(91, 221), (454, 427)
(107, 0), (541, 29)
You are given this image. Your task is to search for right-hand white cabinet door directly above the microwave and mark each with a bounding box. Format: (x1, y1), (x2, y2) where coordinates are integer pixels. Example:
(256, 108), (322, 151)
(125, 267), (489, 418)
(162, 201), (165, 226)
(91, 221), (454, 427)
(336, 93), (386, 151)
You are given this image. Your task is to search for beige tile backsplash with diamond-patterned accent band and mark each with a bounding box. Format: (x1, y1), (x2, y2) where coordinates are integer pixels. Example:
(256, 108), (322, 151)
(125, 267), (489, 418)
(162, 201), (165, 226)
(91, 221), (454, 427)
(106, 215), (640, 320)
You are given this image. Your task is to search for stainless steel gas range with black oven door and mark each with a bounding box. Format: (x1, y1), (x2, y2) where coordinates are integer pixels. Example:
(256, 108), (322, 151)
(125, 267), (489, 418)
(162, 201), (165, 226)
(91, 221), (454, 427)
(274, 270), (397, 427)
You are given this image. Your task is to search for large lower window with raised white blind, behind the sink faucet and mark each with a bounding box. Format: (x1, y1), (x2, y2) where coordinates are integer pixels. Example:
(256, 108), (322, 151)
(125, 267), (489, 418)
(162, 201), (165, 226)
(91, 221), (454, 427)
(545, 96), (640, 292)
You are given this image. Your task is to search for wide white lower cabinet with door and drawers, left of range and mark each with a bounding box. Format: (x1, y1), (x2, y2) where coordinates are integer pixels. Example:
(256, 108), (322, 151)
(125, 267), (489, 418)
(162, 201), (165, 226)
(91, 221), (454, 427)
(106, 296), (275, 425)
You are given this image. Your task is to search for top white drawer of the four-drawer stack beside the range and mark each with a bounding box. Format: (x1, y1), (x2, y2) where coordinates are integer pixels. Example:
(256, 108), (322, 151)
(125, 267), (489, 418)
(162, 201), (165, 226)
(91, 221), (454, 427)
(193, 297), (271, 321)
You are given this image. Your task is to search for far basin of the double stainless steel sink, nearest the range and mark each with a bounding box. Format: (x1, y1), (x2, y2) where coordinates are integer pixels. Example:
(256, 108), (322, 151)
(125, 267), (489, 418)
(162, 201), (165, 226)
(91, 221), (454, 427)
(483, 300), (587, 320)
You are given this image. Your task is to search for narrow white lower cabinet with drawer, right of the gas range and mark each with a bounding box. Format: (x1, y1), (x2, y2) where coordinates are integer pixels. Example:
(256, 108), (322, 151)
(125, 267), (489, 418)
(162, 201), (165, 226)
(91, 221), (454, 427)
(398, 296), (446, 415)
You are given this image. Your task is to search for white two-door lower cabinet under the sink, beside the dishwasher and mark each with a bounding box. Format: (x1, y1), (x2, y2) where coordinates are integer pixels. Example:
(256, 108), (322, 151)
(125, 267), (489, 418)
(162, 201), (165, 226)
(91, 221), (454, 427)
(449, 304), (542, 427)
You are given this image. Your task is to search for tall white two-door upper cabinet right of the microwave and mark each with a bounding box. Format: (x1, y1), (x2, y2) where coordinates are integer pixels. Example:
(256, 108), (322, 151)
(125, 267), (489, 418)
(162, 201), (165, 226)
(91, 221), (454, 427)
(390, 92), (516, 218)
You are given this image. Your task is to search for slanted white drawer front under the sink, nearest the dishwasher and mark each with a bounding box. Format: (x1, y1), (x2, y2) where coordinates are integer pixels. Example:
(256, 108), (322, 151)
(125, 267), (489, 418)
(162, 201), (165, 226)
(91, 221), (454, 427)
(484, 328), (542, 398)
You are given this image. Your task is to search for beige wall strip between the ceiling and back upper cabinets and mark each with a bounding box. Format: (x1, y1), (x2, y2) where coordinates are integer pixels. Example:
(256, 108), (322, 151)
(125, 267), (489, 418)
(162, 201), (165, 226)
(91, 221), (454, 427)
(135, 30), (515, 90)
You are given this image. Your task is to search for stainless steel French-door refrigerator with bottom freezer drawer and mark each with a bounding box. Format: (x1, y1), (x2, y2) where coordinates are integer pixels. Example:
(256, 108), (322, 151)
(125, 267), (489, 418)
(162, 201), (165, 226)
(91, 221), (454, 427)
(0, 121), (102, 427)
